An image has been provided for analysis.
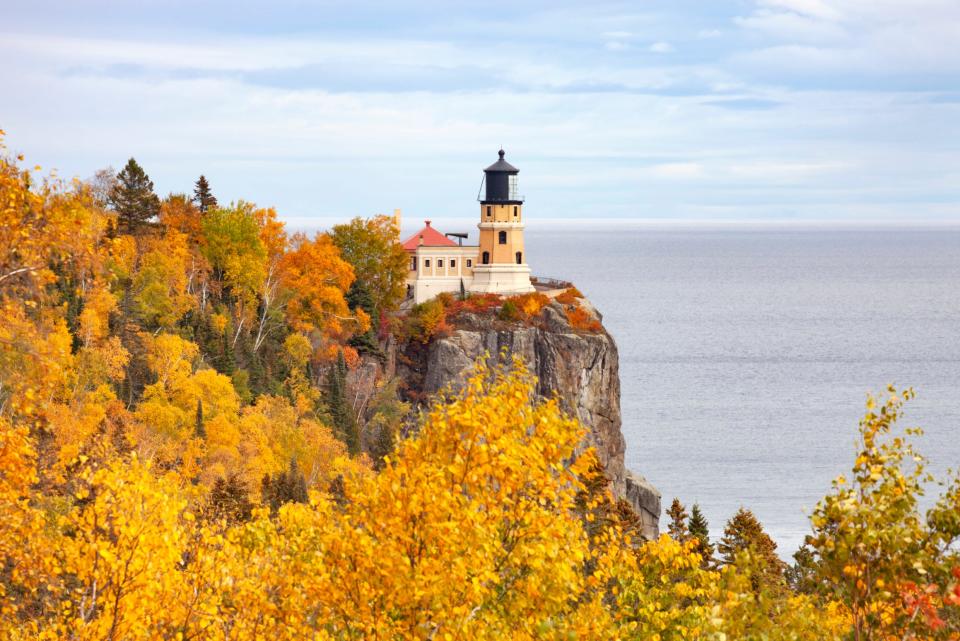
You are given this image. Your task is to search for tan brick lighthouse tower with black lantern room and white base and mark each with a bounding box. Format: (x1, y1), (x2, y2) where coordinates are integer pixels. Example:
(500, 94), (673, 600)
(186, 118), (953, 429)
(470, 149), (534, 294)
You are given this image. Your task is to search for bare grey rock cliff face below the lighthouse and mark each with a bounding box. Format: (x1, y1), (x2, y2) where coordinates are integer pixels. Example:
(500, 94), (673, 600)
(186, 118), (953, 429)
(397, 303), (660, 538)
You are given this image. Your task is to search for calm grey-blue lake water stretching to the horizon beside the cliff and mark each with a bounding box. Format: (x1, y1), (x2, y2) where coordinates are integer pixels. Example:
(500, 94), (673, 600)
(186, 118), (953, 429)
(524, 223), (960, 556)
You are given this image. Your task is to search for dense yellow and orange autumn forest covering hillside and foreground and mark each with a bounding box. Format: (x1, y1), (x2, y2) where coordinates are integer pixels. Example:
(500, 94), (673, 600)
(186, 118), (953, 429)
(0, 132), (960, 640)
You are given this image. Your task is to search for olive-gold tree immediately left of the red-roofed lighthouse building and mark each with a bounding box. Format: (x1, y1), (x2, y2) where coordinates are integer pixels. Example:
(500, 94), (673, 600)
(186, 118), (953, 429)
(330, 216), (409, 321)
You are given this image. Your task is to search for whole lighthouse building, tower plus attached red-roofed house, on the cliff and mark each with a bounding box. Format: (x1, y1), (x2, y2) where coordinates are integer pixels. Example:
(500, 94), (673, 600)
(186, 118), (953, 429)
(403, 149), (533, 303)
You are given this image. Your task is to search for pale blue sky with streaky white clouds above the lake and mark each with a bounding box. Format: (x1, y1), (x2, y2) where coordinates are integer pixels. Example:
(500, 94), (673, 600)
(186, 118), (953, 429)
(0, 0), (960, 226)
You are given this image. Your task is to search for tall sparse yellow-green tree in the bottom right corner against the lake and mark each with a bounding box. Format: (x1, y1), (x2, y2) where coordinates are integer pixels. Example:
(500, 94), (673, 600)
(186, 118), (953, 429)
(806, 387), (960, 639)
